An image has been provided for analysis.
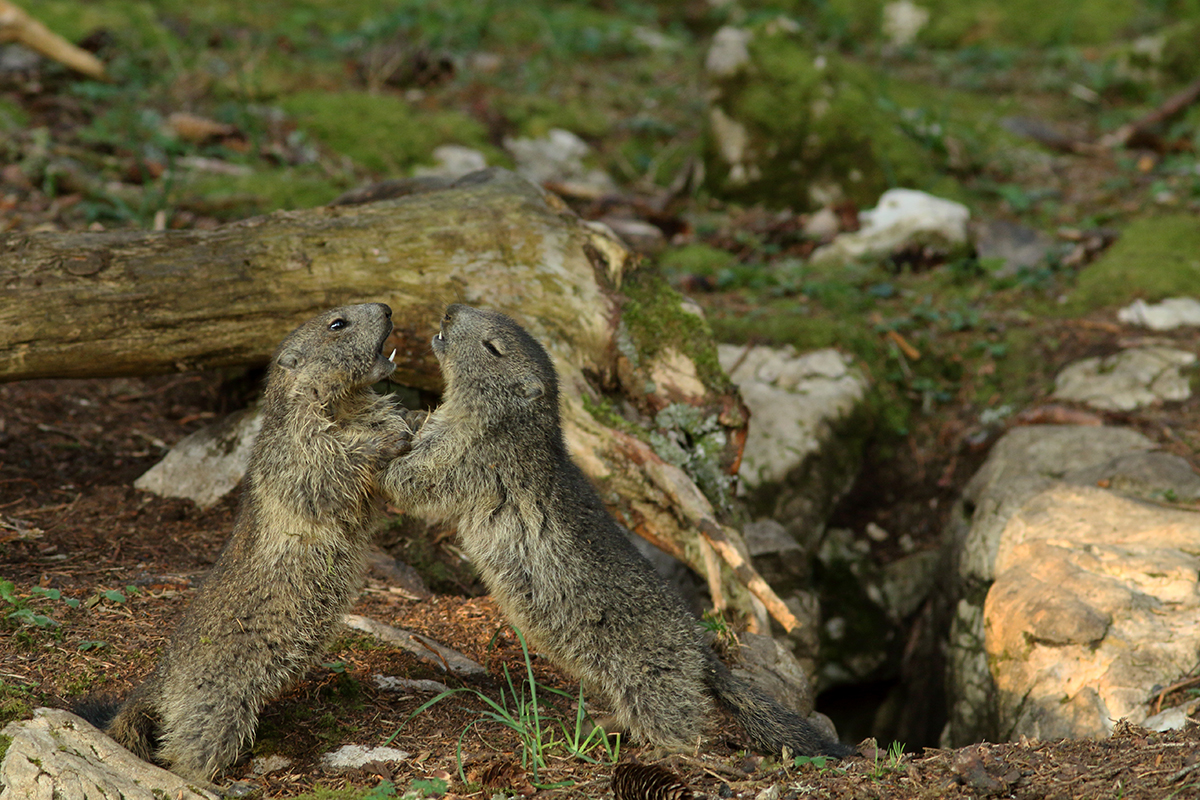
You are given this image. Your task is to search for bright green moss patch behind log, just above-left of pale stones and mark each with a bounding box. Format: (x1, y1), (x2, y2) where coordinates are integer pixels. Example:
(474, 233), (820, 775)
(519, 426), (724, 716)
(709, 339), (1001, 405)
(281, 91), (487, 175)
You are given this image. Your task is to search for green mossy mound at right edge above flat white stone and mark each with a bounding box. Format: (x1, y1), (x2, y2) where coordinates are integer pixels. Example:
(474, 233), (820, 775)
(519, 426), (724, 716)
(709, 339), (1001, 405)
(1063, 213), (1200, 314)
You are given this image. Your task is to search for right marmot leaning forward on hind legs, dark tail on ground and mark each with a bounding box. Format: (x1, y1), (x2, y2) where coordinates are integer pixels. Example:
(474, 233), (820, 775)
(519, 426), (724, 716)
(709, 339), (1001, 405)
(380, 305), (853, 756)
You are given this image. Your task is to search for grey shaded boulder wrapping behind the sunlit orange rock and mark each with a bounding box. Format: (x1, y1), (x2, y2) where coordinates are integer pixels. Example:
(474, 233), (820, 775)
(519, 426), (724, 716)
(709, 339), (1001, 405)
(942, 426), (1200, 746)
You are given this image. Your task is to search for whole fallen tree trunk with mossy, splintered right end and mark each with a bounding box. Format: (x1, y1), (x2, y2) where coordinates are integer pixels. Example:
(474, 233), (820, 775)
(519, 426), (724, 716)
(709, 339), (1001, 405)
(0, 170), (772, 628)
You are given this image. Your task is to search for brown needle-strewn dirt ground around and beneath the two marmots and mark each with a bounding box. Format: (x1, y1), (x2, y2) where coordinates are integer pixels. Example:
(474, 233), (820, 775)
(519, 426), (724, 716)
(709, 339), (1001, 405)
(0, 373), (1200, 800)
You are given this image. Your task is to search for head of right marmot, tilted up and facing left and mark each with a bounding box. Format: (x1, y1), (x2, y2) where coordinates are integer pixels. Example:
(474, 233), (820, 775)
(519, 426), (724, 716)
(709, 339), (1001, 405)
(433, 303), (558, 427)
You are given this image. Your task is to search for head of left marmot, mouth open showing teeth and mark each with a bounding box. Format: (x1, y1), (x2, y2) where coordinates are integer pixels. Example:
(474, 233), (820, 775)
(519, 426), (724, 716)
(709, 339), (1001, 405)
(266, 302), (396, 405)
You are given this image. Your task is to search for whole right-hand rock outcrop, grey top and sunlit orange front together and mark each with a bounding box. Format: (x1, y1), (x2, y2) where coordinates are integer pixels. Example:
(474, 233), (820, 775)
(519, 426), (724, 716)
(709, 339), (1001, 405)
(942, 426), (1200, 746)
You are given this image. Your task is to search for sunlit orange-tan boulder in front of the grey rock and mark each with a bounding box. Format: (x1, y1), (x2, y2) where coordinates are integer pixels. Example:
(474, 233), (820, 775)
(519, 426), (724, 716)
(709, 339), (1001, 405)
(984, 485), (1200, 739)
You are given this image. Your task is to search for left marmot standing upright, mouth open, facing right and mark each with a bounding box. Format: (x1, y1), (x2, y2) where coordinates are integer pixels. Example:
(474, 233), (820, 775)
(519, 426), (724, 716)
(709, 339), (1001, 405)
(96, 303), (408, 781)
